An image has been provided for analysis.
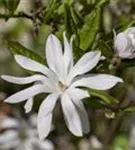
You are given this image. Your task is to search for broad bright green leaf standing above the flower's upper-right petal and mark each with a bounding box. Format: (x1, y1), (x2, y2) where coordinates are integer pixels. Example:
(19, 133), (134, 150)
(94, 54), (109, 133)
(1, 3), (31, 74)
(79, 5), (101, 51)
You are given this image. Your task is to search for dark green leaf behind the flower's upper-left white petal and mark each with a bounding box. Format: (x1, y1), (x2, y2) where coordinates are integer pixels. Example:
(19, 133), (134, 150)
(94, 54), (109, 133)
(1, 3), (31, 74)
(7, 41), (46, 64)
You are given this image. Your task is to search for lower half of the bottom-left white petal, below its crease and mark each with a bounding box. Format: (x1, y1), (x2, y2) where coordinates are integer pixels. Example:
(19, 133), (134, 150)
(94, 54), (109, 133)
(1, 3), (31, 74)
(37, 113), (52, 140)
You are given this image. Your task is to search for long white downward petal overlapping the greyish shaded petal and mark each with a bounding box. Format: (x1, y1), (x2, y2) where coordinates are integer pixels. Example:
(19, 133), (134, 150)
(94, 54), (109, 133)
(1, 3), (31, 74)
(61, 93), (83, 136)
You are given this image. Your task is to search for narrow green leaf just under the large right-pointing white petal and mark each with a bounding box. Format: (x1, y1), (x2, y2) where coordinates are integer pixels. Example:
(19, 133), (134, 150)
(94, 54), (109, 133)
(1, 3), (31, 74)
(88, 89), (118, 104)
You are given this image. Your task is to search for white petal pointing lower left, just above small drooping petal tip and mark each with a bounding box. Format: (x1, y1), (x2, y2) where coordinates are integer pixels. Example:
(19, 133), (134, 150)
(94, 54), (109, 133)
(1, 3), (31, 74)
(5, 85), (50, 103)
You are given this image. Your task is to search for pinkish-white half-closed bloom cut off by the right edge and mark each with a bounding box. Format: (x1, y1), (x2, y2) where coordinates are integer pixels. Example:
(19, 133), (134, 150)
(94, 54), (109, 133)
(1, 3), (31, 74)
(114, 27), (135, 59)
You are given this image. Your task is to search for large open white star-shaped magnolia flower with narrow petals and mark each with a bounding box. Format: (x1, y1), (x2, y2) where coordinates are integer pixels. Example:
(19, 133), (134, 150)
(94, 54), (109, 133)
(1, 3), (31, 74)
(2, 34), (122, 139)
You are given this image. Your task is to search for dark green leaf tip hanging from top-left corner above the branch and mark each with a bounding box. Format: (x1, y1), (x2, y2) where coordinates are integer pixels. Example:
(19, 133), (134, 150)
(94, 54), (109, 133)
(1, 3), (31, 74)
(3, 0), (20, 14)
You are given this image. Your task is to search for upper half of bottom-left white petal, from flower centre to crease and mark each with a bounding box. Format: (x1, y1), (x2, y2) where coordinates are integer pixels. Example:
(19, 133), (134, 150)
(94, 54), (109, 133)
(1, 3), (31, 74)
(38, 93), (59, 118)
